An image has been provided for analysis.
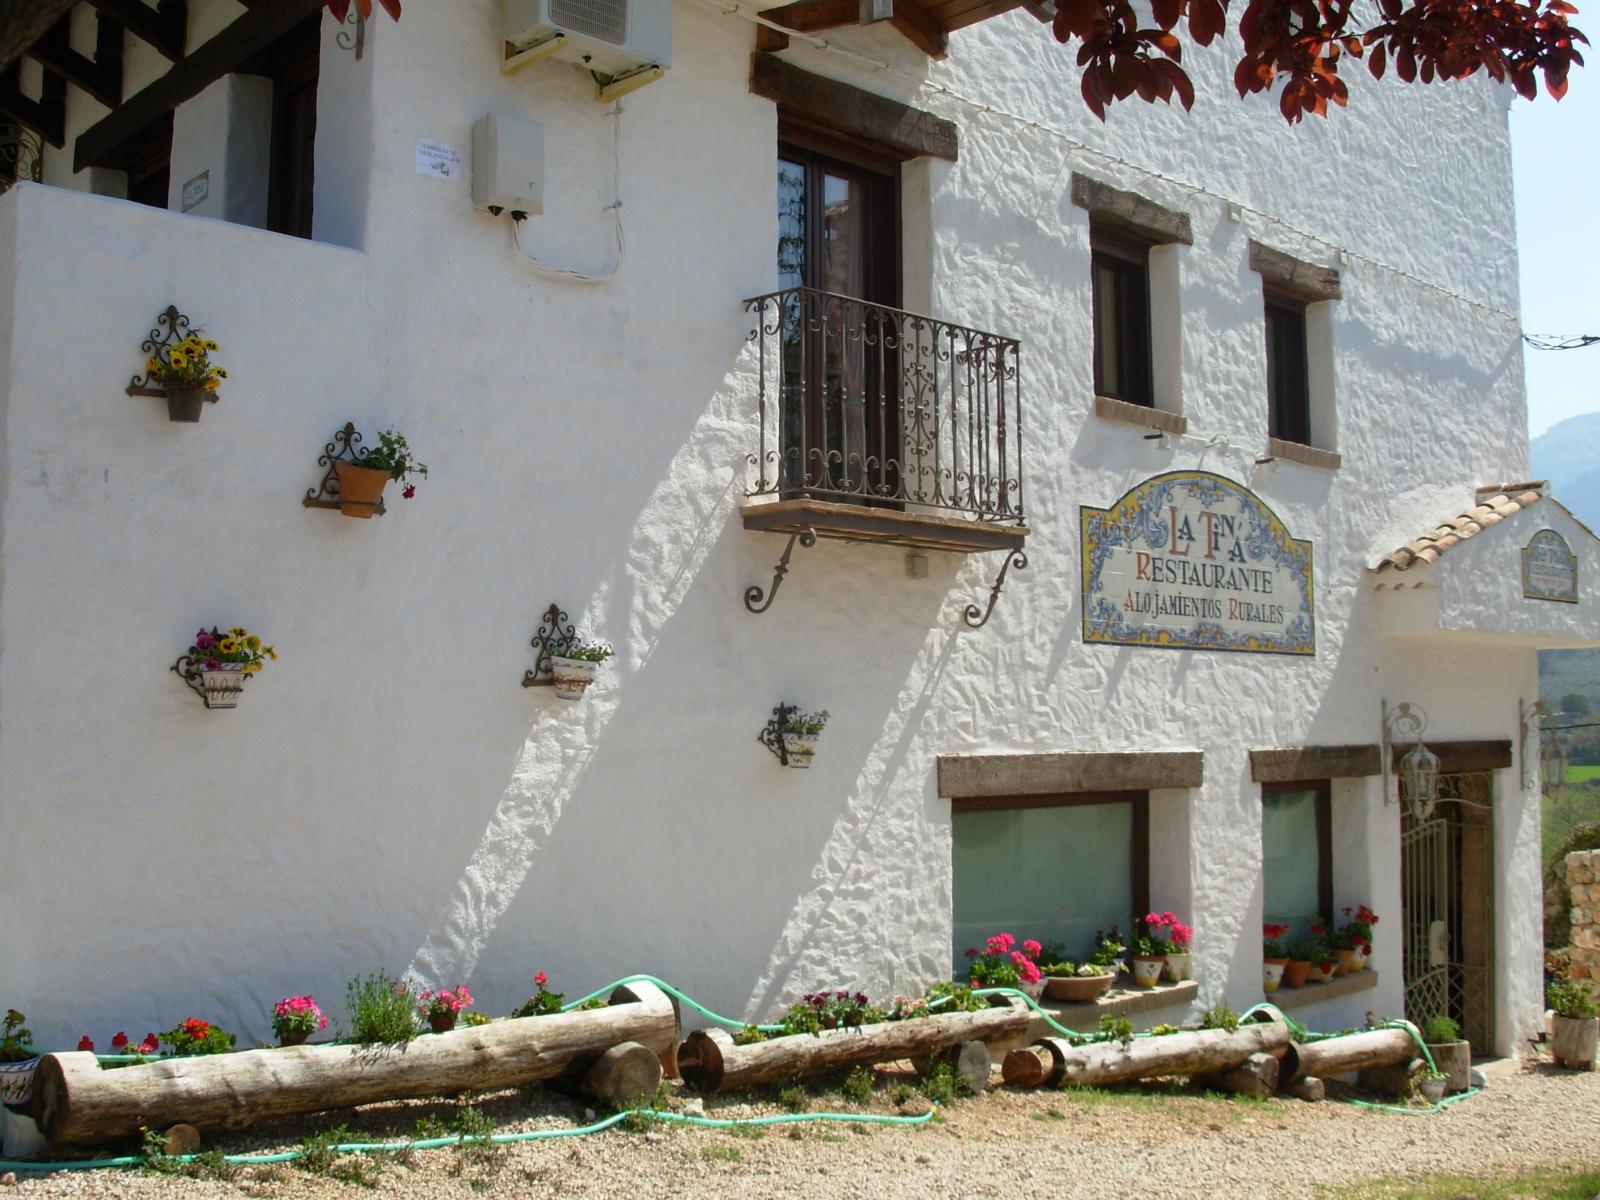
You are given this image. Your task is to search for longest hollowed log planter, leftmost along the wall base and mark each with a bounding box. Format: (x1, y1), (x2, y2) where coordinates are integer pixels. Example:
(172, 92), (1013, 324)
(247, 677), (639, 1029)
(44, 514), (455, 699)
(34, 982), (678, 1146)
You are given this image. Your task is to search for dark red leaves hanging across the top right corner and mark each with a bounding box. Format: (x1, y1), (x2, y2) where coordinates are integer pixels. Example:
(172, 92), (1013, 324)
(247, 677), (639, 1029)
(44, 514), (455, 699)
(1054, 0), (1589, 125)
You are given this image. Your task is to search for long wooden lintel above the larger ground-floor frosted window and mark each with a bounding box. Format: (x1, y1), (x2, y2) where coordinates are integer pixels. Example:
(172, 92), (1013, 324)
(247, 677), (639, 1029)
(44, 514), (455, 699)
(939, 750), (1205, 798)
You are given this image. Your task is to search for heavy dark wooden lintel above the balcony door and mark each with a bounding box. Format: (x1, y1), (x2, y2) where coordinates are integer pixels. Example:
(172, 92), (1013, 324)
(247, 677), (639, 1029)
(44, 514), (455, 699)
(750, 53), (957, 162)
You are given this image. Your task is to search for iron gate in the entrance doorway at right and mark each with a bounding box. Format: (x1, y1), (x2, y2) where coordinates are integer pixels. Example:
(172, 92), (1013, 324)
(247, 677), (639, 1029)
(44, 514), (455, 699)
(1400, 773), (1494, 1053)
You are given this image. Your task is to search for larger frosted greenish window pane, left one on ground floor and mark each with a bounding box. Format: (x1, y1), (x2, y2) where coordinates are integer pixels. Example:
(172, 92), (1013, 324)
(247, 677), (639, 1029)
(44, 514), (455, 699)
(952, 800), (1144, 978)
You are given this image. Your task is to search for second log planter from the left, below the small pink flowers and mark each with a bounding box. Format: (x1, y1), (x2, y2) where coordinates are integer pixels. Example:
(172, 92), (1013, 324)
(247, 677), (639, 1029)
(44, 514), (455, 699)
(678, 997), (1034, 1091)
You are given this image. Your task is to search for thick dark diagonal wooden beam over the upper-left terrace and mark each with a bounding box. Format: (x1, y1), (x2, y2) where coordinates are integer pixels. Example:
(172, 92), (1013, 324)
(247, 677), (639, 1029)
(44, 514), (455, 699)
(72, 0), (323, 171)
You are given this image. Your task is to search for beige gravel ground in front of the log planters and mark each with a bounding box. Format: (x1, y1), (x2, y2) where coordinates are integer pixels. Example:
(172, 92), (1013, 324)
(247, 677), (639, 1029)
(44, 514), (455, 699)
(0, 1061), (1600, 1200)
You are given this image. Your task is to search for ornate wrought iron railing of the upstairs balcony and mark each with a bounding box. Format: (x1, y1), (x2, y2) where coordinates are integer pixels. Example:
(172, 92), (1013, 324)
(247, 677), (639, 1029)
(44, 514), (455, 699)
(744, 288), (1022, 523)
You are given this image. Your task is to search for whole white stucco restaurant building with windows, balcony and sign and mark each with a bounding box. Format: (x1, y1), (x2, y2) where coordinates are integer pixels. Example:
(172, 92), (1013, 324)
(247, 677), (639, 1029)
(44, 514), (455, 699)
(0, 0), (1600, 1053)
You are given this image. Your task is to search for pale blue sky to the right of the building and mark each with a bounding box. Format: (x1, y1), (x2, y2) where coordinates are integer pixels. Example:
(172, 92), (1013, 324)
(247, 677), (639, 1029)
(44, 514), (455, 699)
(1510, 70), (1600, 438)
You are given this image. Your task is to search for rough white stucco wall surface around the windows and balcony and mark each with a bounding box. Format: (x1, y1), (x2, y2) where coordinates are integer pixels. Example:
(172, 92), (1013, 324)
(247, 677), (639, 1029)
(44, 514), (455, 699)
(0, 0), (1539, 1050)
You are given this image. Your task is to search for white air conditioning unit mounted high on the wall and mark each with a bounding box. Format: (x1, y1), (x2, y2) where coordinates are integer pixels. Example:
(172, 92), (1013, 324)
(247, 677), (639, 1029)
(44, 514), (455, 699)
(501, 0), (672, 98)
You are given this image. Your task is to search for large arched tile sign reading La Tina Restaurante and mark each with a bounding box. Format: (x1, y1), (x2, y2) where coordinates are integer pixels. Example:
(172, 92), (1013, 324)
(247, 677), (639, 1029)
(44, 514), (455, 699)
(1080, 470), (1317, 654)
